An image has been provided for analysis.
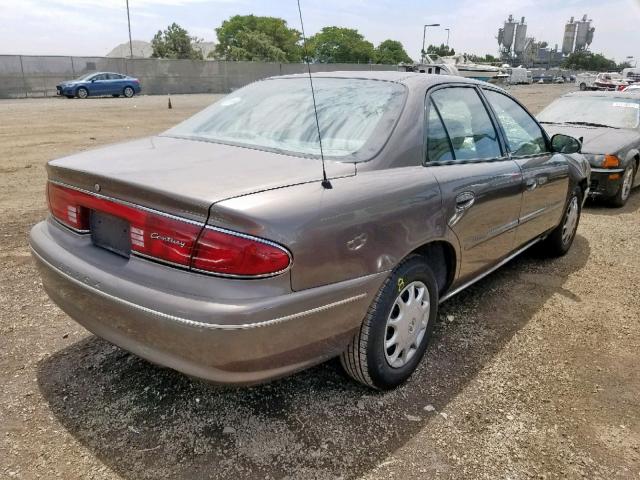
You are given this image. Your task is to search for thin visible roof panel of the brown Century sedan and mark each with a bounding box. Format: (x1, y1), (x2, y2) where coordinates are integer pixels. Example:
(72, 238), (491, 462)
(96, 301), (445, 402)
(262, 70), (493, 87)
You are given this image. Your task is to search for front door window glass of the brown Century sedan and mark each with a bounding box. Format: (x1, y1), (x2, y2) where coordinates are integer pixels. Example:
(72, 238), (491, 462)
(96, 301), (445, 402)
(484, 90), (547, 157)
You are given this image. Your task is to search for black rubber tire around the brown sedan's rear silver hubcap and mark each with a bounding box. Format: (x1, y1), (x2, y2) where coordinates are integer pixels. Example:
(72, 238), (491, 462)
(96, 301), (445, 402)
(340, 255), (438, 390)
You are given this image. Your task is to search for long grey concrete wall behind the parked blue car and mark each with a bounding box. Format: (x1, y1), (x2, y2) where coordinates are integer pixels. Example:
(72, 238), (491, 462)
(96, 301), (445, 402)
(0, 55), (396, 98)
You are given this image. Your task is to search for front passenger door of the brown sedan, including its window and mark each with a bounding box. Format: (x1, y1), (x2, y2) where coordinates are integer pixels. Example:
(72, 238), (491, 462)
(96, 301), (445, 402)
(483, 89), (569, 245)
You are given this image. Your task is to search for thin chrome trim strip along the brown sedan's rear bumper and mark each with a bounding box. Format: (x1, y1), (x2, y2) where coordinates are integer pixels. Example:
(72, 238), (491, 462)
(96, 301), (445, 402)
(30, 246), (367, 330)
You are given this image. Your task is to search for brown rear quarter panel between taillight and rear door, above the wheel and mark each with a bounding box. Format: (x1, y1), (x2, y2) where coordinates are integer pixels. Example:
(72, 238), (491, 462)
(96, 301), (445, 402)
(209, 166), (450, 290)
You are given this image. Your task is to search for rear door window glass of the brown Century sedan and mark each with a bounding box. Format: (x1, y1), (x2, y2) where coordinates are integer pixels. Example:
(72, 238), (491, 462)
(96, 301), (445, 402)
(429, 87), (502, 161)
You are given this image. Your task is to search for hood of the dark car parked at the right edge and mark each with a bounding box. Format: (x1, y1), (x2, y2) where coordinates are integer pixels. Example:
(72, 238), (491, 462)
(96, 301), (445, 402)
(544, 124), (640, 154)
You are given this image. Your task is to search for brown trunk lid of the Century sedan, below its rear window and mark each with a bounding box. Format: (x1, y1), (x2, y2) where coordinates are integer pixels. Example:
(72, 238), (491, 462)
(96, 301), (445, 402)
(47, 136), (356, 221)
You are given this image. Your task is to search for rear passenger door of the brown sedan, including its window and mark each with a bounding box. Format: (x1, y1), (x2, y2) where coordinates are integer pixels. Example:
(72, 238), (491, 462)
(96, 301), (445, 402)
(426, 85), (522, 283)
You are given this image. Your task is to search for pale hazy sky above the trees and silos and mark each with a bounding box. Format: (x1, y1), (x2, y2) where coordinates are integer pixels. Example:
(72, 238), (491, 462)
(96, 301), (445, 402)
(0, 0), (640, 66)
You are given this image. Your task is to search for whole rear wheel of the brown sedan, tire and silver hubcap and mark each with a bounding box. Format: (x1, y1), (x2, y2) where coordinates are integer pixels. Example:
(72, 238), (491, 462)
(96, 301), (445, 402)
(340, 255), (438, 390)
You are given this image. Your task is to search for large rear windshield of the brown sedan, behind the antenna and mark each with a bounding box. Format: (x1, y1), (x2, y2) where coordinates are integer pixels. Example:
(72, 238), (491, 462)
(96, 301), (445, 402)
(164, 78), (405, 161)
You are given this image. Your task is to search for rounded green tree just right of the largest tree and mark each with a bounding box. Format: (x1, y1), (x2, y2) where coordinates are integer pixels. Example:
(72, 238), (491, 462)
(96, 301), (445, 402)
(308, 27), (375, 63)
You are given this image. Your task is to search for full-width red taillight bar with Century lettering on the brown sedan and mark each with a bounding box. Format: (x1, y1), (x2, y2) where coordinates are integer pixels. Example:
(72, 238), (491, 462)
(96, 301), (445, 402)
(48, 183), (291, 277)
